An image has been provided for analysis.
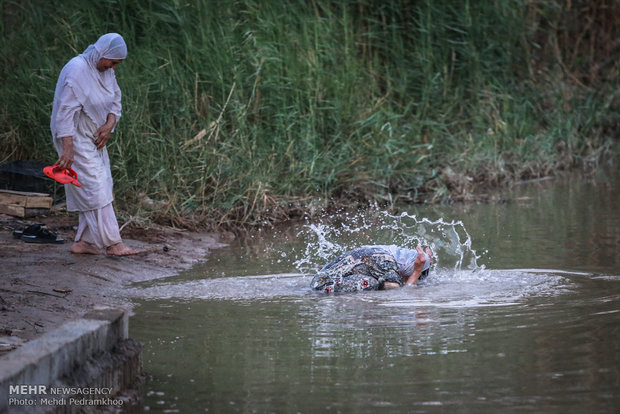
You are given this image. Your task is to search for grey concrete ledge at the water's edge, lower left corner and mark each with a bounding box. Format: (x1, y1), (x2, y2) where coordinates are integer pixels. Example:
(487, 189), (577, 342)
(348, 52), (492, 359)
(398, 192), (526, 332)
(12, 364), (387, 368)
(0, 308), (140, 413)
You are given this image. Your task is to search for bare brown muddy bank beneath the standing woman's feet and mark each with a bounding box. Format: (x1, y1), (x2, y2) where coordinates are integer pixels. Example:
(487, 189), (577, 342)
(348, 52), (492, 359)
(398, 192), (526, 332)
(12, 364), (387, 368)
(0, 214), (226, 354)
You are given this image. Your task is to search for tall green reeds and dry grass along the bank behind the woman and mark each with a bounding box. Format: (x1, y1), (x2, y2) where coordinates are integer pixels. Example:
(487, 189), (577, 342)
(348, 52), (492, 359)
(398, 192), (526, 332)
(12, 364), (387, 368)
(0, 0), (620, 226)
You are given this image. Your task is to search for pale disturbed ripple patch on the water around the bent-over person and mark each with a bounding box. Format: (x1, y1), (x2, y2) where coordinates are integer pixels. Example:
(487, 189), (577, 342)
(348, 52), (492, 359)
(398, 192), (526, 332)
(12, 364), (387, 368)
(131, 269), (573, 308)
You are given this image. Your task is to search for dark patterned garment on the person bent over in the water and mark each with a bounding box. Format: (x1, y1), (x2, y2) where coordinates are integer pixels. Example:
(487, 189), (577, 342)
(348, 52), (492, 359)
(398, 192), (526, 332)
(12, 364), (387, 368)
(310, 247), (405, 293)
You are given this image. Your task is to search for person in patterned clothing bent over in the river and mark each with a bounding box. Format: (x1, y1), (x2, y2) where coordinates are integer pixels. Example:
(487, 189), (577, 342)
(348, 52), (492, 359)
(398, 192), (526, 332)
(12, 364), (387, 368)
(310, 245), (433, 293)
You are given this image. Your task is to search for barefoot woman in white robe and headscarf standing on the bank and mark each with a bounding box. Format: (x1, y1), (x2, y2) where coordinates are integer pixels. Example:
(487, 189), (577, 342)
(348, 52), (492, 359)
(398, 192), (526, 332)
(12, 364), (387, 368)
(50, 33), (138, 256)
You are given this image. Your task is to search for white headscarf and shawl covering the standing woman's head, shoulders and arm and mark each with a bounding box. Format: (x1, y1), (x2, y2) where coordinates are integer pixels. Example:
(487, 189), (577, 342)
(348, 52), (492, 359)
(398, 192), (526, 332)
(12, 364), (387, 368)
(50, 33), (127, 138)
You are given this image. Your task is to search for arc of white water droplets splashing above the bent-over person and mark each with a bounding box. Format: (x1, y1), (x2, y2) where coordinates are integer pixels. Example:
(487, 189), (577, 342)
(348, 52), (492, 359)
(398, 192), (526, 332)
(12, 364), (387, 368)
(294, 210), (484, 273)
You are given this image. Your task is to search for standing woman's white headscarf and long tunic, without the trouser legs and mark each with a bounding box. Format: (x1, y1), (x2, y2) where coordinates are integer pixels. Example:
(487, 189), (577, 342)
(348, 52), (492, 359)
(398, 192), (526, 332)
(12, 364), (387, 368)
(50, 33), (127, 211)
